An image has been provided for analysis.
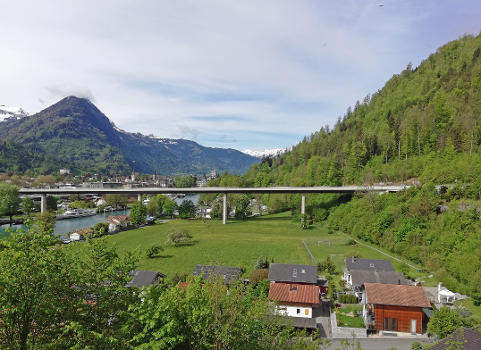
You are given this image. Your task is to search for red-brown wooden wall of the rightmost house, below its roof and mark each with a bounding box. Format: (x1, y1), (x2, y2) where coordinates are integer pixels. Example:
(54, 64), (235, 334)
(374, 305), (423, 333)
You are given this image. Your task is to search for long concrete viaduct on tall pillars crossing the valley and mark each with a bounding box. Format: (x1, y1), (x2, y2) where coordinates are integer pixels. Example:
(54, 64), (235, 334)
(19, 185), (410, 224)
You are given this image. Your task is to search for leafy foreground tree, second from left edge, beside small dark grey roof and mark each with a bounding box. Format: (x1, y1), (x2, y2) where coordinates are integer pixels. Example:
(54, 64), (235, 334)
(63, 239), (140, 350)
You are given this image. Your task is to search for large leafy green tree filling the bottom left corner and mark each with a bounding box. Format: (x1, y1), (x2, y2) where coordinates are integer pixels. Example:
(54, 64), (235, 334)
(0, 231), (78, 350)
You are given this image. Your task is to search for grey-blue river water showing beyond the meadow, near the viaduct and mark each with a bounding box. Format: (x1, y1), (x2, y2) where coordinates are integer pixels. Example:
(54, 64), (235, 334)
(0, 194), (199, 238)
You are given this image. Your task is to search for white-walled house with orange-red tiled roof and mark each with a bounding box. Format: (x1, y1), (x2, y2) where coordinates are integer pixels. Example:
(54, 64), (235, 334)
(269, 283), (319, 328)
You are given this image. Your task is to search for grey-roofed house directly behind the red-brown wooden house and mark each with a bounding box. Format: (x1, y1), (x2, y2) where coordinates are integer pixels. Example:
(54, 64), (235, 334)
(350, 270), (409, 298)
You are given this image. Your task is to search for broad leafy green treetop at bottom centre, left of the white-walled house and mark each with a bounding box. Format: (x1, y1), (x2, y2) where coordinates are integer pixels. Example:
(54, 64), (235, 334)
(130, 278), (319, 350)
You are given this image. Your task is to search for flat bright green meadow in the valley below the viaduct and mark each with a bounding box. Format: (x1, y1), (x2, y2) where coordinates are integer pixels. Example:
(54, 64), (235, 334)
(70, 212), (436, 279)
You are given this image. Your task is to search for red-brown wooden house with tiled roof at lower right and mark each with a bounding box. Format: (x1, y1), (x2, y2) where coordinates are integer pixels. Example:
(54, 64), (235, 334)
(362, 283), (431, 334)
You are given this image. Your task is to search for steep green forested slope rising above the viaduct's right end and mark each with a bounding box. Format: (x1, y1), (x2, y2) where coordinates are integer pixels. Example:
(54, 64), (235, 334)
(246, 35), (481, 186)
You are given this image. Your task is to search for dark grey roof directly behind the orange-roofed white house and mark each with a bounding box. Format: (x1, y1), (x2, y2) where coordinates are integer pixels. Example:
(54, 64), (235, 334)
(267, 263), (317, 284)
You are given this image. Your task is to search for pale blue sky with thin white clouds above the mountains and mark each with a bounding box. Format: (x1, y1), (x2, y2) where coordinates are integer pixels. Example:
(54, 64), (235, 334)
(0, 0), (481, 150)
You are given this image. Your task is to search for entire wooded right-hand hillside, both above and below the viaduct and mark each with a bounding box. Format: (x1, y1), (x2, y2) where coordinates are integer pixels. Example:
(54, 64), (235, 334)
(211, 35), (481, 301)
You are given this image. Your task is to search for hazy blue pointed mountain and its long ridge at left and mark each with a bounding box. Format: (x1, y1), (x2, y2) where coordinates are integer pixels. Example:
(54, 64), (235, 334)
(0, 96), (258, 174)
